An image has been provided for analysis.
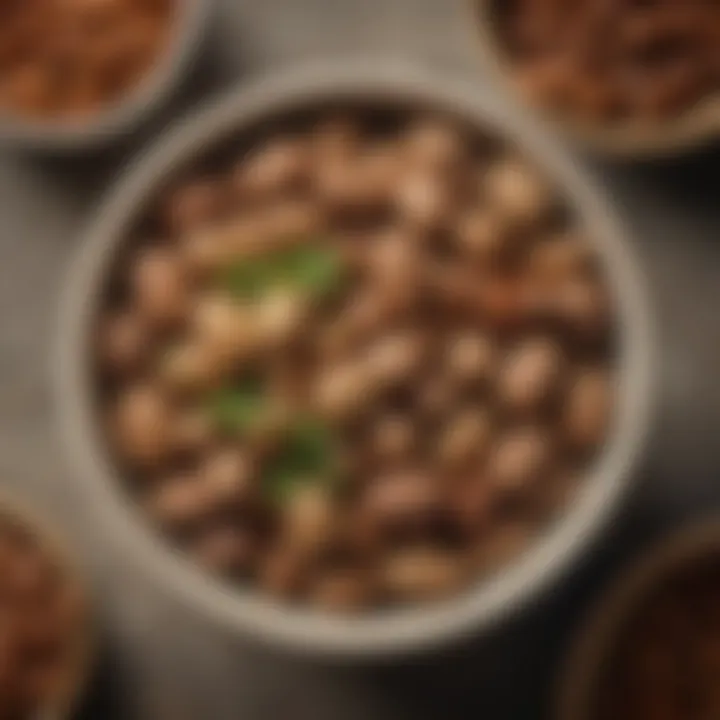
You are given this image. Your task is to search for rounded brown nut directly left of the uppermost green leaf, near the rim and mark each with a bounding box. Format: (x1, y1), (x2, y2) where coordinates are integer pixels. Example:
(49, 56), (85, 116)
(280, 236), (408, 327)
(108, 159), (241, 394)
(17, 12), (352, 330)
(131, 247), (189, 327)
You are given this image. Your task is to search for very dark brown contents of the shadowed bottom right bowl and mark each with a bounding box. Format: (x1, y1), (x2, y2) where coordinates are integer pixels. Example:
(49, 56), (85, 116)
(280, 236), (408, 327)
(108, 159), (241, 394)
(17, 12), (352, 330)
(597, 557), (720, 720)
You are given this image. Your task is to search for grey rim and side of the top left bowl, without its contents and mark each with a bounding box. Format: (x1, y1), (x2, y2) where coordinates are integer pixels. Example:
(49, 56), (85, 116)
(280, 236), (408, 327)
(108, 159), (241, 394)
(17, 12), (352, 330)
(0, 0), (214, 155)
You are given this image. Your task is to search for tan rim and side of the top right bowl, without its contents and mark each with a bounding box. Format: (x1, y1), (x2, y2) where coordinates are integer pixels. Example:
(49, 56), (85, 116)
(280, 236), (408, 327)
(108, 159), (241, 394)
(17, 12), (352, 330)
(469, 0), (720, 160)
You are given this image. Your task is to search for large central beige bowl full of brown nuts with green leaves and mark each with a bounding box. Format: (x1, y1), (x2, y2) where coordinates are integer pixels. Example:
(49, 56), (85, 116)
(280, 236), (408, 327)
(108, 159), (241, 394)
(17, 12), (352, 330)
(57, 64), (651, 655)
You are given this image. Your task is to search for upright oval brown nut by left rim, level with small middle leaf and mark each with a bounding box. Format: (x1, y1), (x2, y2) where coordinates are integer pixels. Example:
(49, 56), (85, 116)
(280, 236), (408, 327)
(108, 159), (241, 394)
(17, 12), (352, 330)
(112, 384), (171, 465)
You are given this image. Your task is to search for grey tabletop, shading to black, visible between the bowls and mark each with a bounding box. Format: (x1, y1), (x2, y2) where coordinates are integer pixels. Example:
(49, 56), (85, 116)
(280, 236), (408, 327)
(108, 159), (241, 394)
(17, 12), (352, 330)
(0, 0), (720, 720)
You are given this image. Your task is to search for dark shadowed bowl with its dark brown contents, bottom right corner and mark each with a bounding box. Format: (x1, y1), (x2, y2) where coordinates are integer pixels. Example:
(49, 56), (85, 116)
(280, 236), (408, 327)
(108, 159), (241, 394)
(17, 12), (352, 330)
(557, 520), (720, 720)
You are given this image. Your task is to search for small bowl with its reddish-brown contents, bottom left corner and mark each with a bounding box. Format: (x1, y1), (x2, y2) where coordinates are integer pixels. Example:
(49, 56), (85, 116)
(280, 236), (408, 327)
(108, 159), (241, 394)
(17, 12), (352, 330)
(0, 495), (93, 720)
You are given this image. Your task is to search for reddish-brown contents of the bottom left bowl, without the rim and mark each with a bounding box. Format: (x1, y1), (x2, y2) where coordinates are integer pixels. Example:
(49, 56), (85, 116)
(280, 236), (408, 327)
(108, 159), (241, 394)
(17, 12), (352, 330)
(0, 516), (84, 720)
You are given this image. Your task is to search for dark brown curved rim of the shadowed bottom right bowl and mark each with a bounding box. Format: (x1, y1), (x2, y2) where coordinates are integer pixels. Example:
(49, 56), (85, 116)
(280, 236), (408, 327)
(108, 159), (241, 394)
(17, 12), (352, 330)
(554, 516), (720, 720)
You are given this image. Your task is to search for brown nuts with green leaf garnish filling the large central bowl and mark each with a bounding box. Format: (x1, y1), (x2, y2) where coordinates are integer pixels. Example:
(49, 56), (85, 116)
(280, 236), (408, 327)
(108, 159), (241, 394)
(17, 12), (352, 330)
(97, 108), (614, 611)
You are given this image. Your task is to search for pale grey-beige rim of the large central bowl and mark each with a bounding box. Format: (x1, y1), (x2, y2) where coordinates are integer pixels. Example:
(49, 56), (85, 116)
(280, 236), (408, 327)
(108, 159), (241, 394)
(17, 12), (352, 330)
(53, 60), (654, 658)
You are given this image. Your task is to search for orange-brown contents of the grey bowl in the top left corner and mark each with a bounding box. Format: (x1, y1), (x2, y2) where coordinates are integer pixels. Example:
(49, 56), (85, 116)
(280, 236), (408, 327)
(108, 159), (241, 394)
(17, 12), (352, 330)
(0, 0), (175, 119)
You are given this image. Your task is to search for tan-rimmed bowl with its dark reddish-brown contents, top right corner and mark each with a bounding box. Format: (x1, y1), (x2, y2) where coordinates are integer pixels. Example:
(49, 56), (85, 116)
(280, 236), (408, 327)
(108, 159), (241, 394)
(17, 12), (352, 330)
(471, 0), (720, 158)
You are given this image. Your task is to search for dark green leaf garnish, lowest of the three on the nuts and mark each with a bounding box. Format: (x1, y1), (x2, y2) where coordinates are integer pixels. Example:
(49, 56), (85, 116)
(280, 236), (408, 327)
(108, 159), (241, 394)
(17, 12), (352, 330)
(263, 419), (336, 504)
